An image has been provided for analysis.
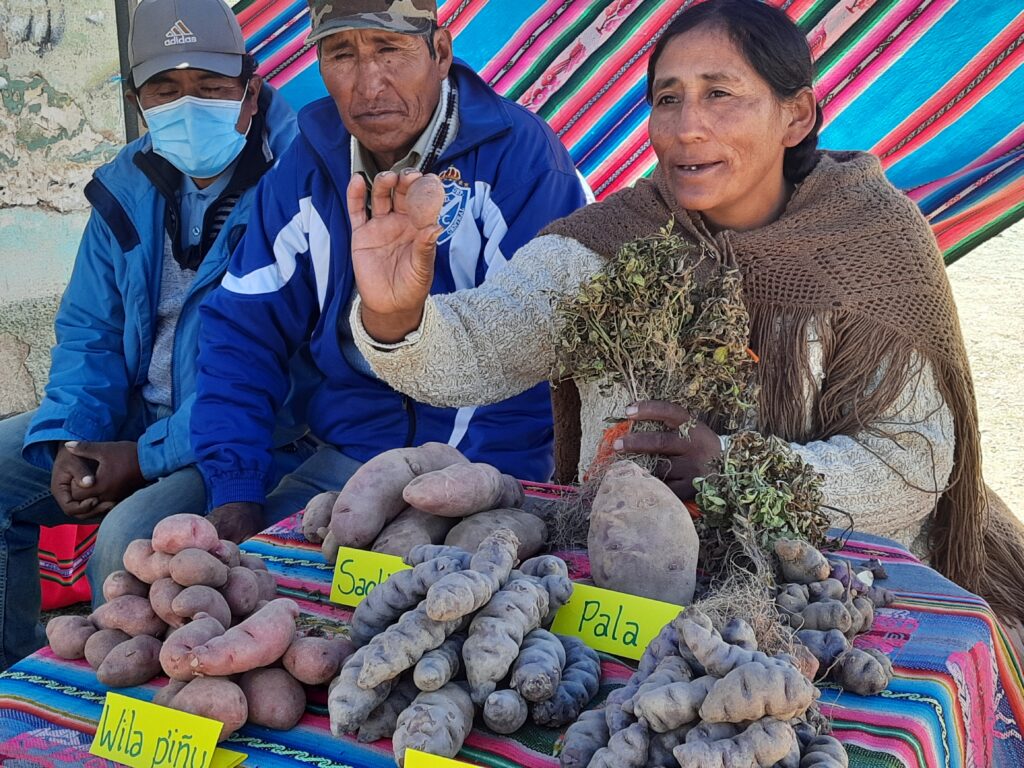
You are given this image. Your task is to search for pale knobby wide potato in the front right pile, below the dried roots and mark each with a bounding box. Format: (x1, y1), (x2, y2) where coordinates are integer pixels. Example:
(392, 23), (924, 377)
(700, 662), (818, 724)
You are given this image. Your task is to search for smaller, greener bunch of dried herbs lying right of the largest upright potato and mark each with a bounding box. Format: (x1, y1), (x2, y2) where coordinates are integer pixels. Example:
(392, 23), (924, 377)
(694, 431), (829, 570)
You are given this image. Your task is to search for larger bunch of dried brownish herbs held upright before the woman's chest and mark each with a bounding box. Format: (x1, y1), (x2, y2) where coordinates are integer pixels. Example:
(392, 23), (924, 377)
(553, 221), (755, 429)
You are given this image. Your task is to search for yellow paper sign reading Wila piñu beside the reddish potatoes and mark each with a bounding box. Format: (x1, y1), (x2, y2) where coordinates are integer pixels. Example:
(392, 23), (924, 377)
(89, 692), (247, 768)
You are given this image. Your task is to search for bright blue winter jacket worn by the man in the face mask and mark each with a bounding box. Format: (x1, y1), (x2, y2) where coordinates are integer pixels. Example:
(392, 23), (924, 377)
(24, 86), (302, 479)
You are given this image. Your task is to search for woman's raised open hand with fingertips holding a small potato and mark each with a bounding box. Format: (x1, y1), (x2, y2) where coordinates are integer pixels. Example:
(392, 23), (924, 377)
(348, 171), (444, 343)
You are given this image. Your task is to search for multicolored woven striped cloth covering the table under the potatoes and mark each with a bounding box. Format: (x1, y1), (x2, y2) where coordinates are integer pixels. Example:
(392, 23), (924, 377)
(0, 486), (1024, 768)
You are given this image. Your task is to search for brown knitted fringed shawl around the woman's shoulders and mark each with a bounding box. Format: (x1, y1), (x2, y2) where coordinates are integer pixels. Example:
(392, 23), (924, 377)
(545, 153), (1024, 616)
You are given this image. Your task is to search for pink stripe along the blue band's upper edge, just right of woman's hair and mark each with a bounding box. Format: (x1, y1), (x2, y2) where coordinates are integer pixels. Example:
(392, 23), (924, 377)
(816, 0), (956, 123)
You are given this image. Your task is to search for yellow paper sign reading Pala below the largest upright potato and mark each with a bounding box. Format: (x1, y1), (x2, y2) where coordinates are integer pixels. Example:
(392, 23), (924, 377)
(551, 584), (682, 659)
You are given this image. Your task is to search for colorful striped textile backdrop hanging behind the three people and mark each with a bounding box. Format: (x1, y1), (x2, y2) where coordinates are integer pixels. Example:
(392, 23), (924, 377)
(234, 0), (1024, 263)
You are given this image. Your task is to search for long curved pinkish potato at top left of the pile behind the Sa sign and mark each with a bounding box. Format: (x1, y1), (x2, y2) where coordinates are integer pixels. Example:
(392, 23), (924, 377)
(331, 442), (468, 549)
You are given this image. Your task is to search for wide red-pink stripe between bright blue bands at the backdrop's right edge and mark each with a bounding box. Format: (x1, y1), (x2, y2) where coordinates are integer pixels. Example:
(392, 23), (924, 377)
(870, 12), (1024, 167)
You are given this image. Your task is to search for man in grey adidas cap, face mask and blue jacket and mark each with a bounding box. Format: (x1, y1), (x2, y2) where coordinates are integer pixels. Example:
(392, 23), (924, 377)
(0, 0), (305, 669)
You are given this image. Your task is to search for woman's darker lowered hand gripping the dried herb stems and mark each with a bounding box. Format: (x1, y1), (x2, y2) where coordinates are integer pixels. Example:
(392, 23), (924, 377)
(613, 400), (722, 502)
